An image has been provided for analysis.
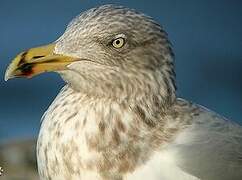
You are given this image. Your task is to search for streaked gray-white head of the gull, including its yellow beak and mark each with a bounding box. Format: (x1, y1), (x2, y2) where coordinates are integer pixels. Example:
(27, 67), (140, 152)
(5, 5), (176, 100)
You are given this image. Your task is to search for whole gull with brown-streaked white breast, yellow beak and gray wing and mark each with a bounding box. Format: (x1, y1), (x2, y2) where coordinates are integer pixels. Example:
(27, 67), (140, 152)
(5, 5), (242, 180)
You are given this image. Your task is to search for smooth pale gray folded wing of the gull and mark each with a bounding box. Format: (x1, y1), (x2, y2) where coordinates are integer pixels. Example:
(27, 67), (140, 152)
(170, 99), (242, 180)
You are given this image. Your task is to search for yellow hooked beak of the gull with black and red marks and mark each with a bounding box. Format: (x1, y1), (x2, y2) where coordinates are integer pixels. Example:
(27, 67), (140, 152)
(5, 44), (77, 81)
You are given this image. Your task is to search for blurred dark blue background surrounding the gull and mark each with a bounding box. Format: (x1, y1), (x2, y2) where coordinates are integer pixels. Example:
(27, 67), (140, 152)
(0, 0), (242, 180)
